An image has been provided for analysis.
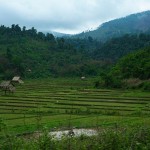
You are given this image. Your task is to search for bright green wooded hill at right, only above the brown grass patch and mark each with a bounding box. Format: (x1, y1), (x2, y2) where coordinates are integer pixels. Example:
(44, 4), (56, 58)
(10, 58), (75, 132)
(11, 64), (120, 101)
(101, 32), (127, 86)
(111, 47), (150, 79)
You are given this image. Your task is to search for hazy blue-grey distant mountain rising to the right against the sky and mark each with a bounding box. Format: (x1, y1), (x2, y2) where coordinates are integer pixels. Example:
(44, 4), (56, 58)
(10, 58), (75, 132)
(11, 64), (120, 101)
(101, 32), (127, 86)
(73, 11), (150, 41)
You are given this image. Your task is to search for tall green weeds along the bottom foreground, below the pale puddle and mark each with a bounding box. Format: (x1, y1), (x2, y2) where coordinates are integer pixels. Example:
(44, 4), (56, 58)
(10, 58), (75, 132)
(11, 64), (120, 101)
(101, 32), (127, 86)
(0, 127), (150, 150)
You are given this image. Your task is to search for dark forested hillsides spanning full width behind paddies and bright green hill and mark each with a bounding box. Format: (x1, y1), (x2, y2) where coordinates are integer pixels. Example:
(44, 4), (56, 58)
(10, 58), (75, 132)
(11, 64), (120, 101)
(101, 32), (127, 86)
(0, 25), (150, 79)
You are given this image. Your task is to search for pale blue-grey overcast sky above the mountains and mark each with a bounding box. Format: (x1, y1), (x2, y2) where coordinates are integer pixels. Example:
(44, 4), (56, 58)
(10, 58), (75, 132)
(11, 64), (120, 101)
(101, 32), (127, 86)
(0, 0), (150, 34)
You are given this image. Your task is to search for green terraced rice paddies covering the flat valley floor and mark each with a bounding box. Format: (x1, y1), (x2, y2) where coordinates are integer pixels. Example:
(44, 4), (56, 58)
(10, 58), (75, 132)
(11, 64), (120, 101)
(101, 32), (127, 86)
(0, 79), (150, 134)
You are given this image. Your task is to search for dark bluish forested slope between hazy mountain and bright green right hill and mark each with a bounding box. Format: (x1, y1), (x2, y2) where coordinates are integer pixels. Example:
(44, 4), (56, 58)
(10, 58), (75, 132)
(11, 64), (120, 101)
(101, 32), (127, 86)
(93, 34), (150, 62)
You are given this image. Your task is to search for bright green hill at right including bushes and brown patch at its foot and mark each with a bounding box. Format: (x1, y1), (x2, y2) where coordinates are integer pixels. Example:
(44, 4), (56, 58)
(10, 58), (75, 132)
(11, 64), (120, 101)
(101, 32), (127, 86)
(95, 47), (150, 91)
